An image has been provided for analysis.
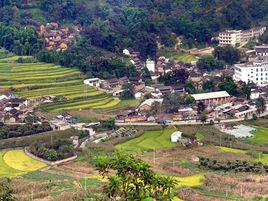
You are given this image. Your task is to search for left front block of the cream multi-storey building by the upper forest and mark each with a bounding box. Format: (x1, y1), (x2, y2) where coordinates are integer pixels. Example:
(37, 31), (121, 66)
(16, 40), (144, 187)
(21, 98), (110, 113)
(219, 30), (242, 46)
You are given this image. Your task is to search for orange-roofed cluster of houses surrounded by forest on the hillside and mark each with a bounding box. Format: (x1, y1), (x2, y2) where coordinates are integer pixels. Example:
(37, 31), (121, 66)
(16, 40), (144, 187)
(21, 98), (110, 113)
(38, 22), (79, 51)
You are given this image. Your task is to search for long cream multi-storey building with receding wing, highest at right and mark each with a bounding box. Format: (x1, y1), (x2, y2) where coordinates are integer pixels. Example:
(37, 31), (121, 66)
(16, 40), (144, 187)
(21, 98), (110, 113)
(219, 26), (266, 46)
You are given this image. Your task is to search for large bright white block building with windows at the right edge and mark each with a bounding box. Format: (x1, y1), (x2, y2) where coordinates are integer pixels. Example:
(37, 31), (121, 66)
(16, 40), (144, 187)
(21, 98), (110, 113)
(234, 59), (268, 86)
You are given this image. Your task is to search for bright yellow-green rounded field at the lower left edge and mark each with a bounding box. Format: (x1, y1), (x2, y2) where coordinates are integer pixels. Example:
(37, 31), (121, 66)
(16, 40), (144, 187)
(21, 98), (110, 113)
(0, 150), (46, 177)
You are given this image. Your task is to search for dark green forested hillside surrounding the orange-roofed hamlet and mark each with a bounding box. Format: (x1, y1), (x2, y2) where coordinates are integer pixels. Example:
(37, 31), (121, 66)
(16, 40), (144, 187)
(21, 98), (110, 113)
(0, 0), (268, 79)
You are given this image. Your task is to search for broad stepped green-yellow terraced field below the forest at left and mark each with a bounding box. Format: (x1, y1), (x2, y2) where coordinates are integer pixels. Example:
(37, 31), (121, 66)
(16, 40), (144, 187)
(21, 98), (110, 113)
(0, 57), (120, 112)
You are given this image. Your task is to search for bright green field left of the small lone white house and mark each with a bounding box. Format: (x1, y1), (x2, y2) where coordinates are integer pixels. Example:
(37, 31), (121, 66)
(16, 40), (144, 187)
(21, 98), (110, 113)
(116, 129), (177, 151)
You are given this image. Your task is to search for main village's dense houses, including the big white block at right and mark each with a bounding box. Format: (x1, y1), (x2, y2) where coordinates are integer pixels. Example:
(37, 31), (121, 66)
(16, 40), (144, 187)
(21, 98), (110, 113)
(113, 45), (268, 123)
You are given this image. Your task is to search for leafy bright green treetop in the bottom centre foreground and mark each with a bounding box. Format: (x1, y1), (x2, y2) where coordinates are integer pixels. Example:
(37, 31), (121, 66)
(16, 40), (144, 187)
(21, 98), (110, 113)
(96, 152), (176, 201)
